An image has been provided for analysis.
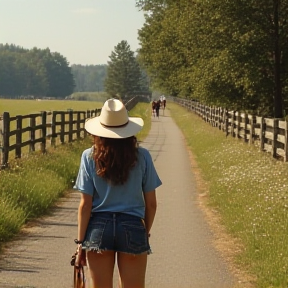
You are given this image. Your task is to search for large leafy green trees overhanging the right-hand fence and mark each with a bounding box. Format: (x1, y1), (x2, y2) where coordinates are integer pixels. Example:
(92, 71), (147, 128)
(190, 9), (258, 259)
(136, 0), (288, 118)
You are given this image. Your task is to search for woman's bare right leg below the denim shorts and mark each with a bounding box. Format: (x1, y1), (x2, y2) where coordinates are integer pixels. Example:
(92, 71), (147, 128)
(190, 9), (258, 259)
(117, 252), (147, 288)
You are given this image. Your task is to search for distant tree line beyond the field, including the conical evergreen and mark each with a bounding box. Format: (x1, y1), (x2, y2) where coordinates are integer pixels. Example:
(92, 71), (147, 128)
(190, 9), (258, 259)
(0, 40), (151, 100)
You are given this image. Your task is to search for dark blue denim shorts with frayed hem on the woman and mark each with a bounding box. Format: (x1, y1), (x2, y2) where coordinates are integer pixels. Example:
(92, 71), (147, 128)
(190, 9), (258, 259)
(82, 212), (151, 254)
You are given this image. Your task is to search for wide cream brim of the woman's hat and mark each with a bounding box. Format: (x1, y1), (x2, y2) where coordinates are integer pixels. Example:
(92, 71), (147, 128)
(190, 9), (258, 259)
(85, 116), (144, 139)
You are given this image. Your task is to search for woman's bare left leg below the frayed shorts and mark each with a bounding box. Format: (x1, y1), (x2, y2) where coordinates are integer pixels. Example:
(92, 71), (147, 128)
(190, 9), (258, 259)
(87, 251), (115, 288)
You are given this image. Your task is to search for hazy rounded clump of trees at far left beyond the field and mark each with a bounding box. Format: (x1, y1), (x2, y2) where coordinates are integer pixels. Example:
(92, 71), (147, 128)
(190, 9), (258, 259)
(0, 44), (75, 98)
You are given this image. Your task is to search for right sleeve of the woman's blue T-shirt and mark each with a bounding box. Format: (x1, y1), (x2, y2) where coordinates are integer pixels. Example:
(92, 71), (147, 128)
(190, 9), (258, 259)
(142, 149), (162, 193)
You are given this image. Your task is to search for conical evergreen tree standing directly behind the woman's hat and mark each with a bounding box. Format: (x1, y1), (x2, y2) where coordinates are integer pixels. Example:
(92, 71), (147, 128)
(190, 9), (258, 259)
(104, 40), (141, 98)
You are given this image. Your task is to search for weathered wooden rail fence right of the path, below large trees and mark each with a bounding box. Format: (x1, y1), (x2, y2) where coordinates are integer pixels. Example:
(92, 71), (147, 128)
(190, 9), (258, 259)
(171, 97), (288, 162)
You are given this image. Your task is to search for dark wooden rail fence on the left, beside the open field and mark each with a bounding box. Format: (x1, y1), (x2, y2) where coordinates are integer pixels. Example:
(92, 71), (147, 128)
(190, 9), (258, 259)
(0, 97), (138, 169)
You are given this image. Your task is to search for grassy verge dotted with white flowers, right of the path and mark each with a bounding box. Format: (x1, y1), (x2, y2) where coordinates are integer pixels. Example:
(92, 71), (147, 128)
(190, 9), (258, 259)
(168, 103), (288, 288)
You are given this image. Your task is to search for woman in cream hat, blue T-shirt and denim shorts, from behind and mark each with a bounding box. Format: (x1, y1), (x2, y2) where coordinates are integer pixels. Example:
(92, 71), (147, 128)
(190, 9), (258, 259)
(74, 99), (162, 288)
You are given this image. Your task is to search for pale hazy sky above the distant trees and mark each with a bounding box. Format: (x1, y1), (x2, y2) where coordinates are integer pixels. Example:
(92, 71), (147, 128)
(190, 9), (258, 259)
(0, 0), (145, 65)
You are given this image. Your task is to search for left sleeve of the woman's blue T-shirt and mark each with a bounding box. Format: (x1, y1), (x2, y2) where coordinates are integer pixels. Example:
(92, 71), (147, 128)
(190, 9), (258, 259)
(73, 150), (94, 196)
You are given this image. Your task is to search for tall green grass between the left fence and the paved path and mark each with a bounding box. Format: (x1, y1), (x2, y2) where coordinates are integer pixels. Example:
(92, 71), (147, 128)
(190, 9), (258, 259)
(0, 103), (151, 252)
